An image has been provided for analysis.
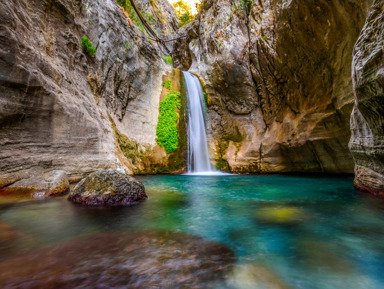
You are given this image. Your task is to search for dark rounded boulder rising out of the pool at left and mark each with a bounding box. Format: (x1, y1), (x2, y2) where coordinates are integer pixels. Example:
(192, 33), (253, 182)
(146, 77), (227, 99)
(68, 170), (148, 206)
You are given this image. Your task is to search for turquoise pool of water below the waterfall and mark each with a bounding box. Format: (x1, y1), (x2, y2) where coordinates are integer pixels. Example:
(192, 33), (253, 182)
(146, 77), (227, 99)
(0, 175), (384, 289)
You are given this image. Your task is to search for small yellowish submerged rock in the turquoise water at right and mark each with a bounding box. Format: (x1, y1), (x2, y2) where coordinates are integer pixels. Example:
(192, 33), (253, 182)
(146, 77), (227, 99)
(255, 207), (308, 225)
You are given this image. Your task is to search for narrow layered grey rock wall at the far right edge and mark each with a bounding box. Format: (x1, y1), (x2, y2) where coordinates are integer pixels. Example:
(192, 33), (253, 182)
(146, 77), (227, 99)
(349, 0), (384, 195)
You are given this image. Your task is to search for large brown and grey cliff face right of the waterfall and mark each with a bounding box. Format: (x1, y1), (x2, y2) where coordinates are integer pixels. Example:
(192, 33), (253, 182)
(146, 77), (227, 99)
(174, 0), (371, 173)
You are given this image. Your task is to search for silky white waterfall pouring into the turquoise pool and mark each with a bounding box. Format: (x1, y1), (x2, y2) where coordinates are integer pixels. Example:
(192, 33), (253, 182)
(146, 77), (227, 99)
(183, 71), (214, 174)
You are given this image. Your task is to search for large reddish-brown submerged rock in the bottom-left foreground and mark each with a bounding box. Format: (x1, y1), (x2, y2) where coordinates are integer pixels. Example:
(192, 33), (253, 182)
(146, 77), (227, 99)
(0, 232), (234, 289)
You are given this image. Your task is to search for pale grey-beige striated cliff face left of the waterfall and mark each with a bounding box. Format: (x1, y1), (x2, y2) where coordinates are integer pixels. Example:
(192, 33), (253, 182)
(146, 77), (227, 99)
(0, 0), (177, 187)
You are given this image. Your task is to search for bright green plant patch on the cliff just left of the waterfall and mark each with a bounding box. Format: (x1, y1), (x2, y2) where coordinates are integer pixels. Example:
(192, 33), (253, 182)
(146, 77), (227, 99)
(156, 91), (181, 154)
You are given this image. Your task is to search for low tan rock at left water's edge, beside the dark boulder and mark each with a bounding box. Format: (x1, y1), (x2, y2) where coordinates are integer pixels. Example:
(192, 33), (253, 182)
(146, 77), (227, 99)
(0, 170), (69, 198)
